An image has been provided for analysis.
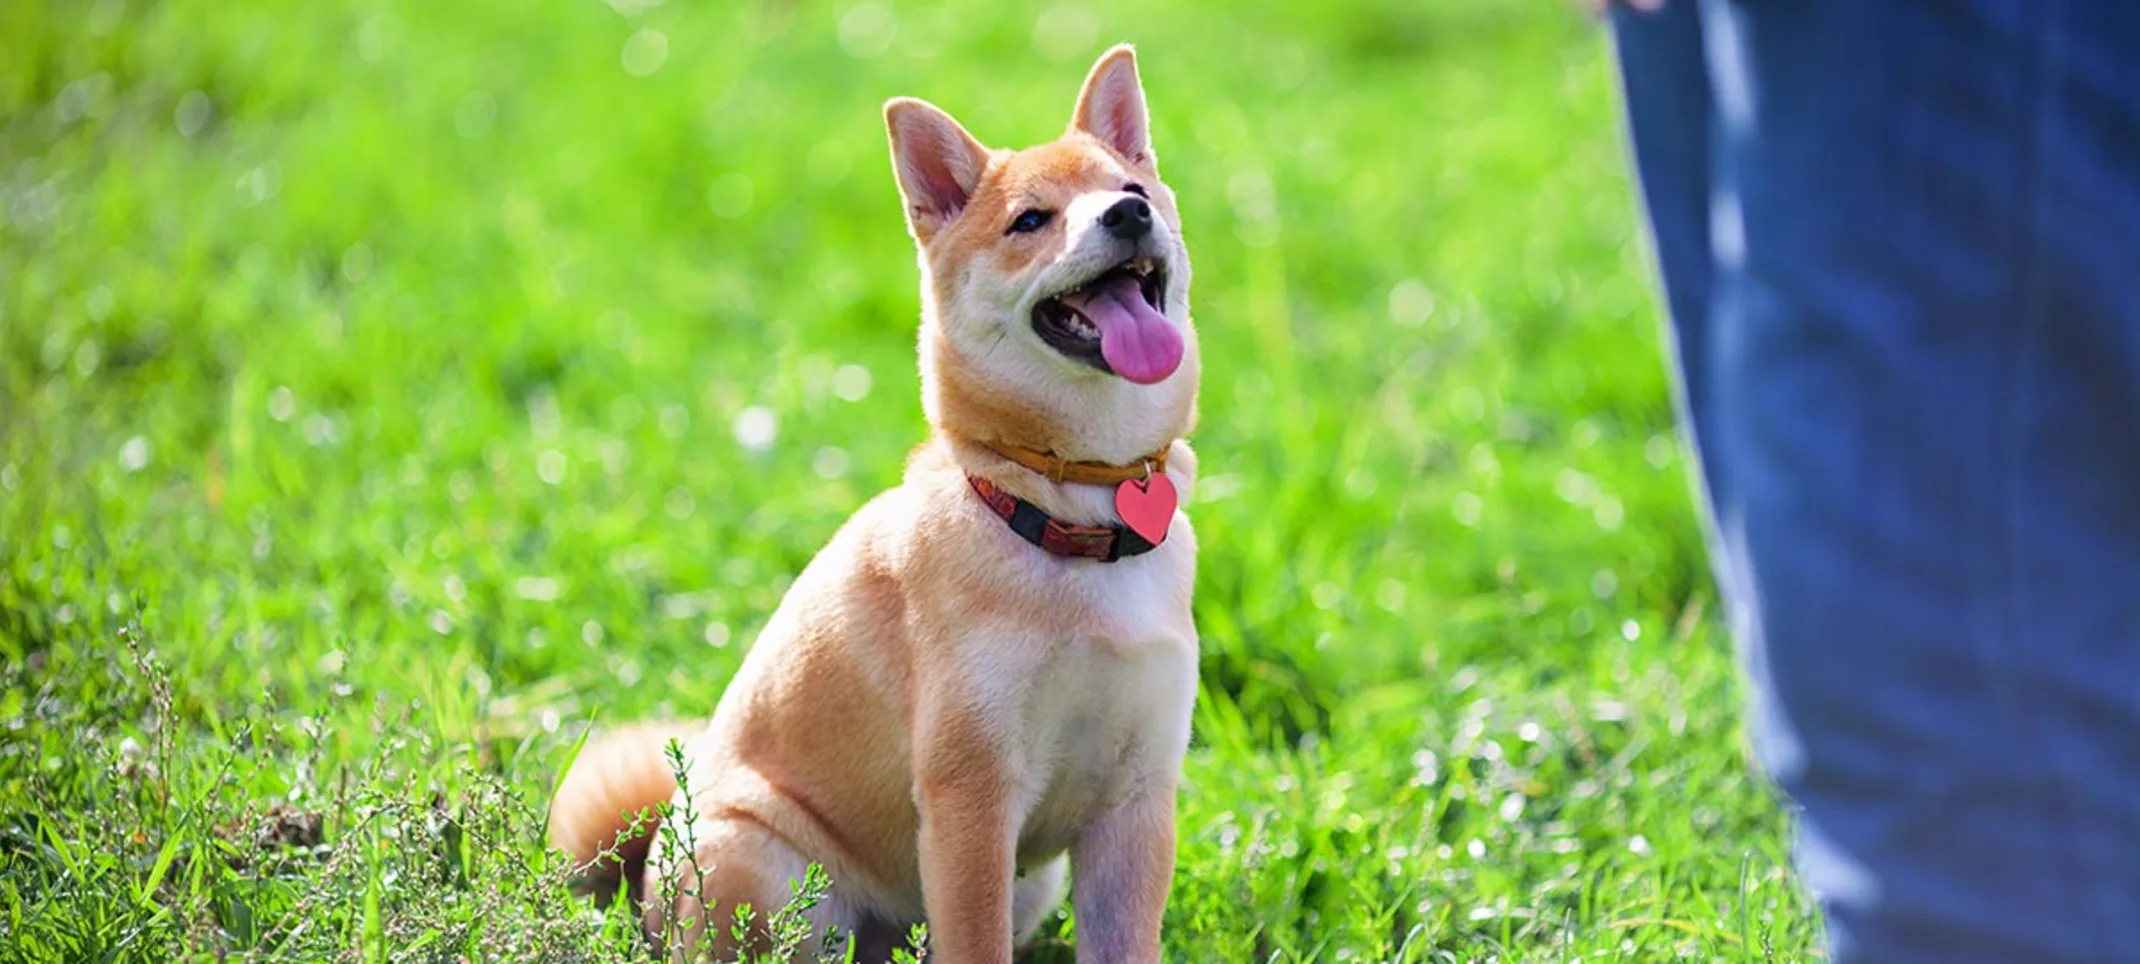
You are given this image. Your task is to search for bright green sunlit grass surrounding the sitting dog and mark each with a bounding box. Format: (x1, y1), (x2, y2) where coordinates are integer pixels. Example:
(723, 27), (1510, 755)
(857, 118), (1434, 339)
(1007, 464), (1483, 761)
(0, 0), (1817, 964)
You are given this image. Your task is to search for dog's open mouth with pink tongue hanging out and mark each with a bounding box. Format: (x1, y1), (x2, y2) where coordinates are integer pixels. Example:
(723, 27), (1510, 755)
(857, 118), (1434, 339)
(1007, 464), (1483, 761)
(1034, 257), (1181, 386)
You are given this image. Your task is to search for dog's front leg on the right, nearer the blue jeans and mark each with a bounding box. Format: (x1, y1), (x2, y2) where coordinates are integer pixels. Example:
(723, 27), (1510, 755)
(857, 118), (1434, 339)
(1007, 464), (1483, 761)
(1070, 780), (1175, 964)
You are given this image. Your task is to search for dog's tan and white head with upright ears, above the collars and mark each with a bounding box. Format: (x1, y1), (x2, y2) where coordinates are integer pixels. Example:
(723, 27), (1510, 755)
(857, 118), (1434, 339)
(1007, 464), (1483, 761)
(884, 47), (1196, 463)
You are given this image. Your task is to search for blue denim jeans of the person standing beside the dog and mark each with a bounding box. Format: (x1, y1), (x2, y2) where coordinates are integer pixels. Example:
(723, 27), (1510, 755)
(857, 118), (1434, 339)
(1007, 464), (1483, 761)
(1614, 0), (2140, 964)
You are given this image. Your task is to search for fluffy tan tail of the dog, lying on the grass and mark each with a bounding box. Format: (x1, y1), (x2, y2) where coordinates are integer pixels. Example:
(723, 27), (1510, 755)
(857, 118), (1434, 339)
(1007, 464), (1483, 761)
(550, 722), (704, 904)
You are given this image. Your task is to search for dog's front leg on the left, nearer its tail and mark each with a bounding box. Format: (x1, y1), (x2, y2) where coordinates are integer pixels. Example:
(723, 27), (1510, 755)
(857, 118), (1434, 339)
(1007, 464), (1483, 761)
(918, 726), (1014, 964)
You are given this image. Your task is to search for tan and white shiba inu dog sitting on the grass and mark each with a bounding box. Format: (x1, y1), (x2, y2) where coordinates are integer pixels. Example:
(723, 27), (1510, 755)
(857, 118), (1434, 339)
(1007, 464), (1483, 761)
(550, 47), (1198, 964)
